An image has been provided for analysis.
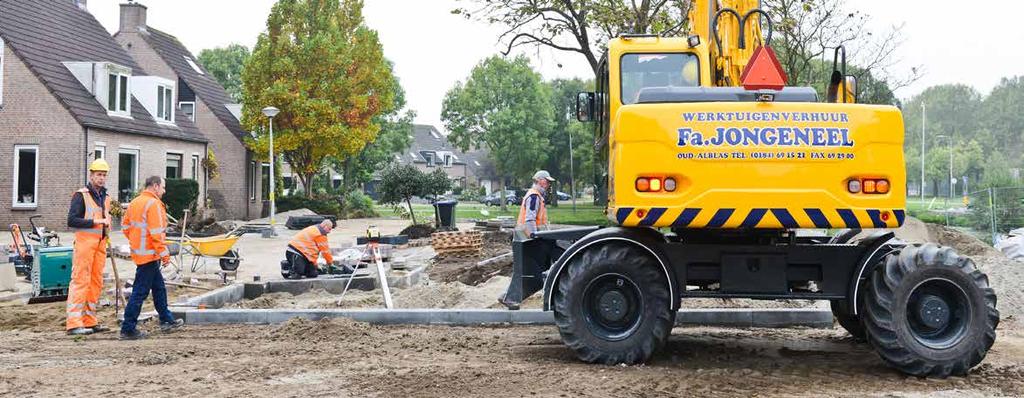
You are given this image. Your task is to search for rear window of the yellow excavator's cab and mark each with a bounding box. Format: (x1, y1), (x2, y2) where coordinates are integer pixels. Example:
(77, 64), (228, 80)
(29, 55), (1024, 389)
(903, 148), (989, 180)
(621, 53), (700, 105)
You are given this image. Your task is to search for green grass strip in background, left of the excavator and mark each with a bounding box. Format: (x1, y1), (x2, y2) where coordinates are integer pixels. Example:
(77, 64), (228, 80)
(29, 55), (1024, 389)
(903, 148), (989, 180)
(377, 202), (608, 225)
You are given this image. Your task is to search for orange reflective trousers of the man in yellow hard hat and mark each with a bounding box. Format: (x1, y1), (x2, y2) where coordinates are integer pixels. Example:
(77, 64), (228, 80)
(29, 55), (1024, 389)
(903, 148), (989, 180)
(65, 238), (106, 330)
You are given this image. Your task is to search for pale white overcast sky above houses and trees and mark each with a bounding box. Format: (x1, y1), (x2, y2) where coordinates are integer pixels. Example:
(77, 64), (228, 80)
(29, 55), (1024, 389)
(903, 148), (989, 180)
(88, 0), (1024, 130)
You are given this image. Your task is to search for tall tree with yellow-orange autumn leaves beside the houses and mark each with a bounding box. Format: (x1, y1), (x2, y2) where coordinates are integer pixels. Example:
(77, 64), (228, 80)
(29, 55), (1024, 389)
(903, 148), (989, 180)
(242, 0), (396, 196)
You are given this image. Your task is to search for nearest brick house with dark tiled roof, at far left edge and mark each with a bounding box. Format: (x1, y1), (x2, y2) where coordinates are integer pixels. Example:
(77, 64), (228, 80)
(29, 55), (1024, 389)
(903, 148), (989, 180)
(0, 0), (208, 229)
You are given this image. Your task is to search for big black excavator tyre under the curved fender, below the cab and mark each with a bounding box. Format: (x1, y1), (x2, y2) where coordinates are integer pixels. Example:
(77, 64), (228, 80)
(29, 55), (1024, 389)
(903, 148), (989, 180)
(554, 240), (676, 364)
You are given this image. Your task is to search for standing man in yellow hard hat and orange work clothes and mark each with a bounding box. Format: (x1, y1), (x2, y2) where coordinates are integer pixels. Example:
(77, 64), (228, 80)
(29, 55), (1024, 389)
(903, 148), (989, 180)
(65, 159), (111, 336)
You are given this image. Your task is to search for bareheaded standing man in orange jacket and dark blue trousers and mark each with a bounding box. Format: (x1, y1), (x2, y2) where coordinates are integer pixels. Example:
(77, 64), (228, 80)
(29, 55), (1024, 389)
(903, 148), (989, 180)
(121, 176), (184, 340)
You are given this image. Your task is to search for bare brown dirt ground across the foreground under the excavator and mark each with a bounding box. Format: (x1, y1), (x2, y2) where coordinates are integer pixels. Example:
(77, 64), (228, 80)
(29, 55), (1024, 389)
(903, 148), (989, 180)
(0, 319), (1024, 397)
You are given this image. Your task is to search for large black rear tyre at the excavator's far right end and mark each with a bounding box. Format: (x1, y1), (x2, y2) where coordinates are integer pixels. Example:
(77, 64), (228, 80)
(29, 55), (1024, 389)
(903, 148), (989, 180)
(864, 244), (999, 378)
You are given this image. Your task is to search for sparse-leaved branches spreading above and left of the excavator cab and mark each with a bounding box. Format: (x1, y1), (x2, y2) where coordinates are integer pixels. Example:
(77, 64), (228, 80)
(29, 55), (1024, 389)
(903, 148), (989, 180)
(452, 0), (690, 76)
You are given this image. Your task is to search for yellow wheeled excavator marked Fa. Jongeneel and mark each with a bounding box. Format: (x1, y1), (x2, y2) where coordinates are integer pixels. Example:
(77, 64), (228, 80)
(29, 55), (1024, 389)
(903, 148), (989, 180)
(501, 0), (999, 378)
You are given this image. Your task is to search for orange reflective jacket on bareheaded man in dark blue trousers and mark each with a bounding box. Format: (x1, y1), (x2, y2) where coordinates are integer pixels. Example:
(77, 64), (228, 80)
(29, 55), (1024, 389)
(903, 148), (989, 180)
(121, 191), (170, 265)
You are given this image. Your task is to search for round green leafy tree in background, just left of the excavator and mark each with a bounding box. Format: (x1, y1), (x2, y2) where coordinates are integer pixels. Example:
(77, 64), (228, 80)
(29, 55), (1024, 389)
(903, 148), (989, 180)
(441, 56), (554, 208)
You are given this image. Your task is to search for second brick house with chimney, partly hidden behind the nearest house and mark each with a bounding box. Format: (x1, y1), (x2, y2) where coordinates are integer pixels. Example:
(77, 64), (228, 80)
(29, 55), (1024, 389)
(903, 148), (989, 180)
(114, 3), (270, 220)
